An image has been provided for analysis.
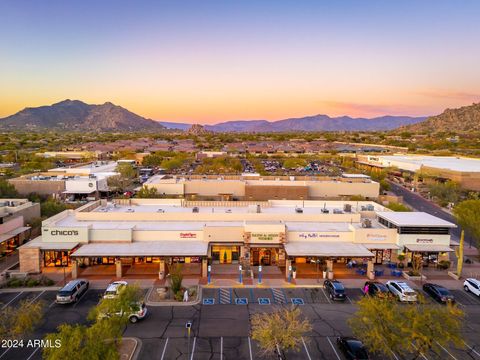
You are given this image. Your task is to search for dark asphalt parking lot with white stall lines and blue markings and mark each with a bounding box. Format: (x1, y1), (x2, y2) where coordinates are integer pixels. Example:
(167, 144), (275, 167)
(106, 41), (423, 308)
(0, 288), (480, 360)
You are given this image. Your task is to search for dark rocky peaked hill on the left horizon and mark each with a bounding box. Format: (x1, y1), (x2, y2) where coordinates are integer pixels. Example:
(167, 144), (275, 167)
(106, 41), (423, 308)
(0, 100), (165, 131)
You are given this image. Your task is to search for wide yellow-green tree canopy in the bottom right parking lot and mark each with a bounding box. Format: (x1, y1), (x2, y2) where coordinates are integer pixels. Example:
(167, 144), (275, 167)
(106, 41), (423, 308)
(348, 296), (464, 359)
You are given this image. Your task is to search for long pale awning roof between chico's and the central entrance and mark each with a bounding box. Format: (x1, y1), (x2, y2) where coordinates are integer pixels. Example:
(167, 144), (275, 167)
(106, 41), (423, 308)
(72, 241), (208, 257)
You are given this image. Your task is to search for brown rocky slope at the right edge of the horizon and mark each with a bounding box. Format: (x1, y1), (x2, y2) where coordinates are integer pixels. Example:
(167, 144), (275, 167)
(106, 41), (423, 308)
(405, 103), (480, 132)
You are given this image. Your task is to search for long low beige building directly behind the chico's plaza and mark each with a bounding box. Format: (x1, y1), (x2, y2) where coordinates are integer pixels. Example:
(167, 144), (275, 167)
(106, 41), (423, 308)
(144, 174), (380, 201)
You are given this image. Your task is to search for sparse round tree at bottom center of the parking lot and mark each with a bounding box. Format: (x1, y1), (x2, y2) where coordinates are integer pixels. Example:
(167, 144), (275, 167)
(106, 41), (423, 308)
(251, 307), (312, 356)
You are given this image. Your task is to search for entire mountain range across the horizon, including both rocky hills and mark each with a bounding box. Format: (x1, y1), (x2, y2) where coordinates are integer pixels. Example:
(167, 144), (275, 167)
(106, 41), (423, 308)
(6, 100), (480, 132)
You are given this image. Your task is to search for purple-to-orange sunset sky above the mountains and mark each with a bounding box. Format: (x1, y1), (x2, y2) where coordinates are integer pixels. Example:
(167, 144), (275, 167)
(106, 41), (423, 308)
(0, 0), (480, 123)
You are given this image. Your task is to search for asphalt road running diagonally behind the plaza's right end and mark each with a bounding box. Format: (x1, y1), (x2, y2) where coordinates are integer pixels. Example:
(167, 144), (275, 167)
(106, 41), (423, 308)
(389, 181), (475, 245)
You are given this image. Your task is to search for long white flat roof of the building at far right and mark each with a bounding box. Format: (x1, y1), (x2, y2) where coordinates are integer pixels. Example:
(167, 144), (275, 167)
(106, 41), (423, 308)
(380, 155), (480, 172)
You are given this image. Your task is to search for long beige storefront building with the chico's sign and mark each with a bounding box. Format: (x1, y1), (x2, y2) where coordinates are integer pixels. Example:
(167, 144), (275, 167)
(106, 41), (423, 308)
(19, 199), (455, 278)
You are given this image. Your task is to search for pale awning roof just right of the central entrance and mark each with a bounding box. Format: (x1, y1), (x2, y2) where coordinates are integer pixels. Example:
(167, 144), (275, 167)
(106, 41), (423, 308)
(285, 241), (373, 257)
